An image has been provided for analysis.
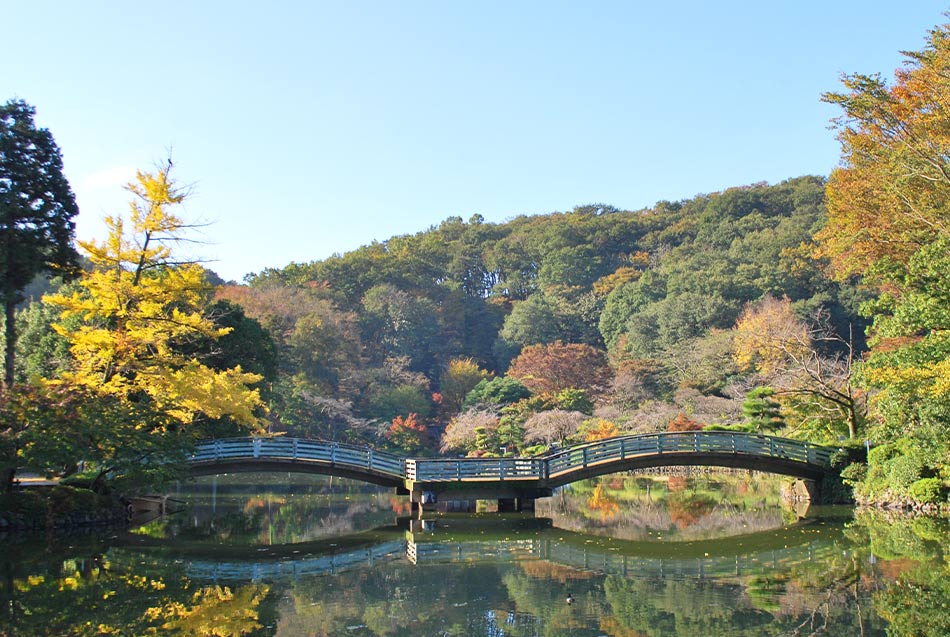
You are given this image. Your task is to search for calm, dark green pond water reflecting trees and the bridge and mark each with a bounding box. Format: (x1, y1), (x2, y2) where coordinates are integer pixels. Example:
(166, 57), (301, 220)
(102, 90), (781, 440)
(0, 472), (950, 637)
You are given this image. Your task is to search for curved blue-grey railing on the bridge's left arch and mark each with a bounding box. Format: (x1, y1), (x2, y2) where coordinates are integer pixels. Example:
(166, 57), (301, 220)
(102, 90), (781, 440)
(191, 437), (405, 477)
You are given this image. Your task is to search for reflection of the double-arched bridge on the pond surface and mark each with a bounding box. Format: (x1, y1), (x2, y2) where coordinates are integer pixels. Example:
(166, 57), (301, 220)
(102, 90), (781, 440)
(180, 520), (839, 582)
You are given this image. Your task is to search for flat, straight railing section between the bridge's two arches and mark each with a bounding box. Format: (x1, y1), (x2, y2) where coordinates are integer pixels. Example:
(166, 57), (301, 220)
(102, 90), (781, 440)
(406, 458), (545, 482)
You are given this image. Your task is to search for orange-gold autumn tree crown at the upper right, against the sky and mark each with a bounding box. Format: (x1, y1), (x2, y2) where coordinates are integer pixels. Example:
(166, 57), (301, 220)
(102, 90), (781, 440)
(818, 25), (950, 285)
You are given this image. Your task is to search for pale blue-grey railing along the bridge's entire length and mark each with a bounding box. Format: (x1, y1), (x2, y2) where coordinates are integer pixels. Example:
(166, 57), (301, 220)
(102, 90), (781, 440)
(191, 431), (834, 483)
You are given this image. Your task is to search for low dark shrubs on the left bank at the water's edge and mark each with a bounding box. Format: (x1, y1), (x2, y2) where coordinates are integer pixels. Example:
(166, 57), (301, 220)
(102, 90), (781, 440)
(0, 485), (129, 536)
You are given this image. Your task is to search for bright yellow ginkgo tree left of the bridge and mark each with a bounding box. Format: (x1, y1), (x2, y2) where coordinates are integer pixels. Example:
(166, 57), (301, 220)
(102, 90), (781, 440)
(44, 162), (262, 429)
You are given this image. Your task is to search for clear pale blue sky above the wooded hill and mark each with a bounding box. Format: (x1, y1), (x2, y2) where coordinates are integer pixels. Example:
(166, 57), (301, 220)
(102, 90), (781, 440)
(7, 0), (947, 280)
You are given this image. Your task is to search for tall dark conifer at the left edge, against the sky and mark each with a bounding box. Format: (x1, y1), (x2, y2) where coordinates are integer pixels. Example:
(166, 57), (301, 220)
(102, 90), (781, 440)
(0, 100), (79, 388)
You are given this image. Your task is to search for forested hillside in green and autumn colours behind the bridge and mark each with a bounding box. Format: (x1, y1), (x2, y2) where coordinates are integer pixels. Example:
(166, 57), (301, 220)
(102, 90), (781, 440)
(199, 177), (862, 453)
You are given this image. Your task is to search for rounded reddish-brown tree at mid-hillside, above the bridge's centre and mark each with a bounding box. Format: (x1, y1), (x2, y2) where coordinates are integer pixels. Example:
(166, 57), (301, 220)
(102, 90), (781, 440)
(508, 342), (610, 393)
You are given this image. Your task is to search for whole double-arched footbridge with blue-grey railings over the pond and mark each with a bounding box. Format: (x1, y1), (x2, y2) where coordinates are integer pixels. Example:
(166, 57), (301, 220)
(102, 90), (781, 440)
(189, 431), (835, 510)
